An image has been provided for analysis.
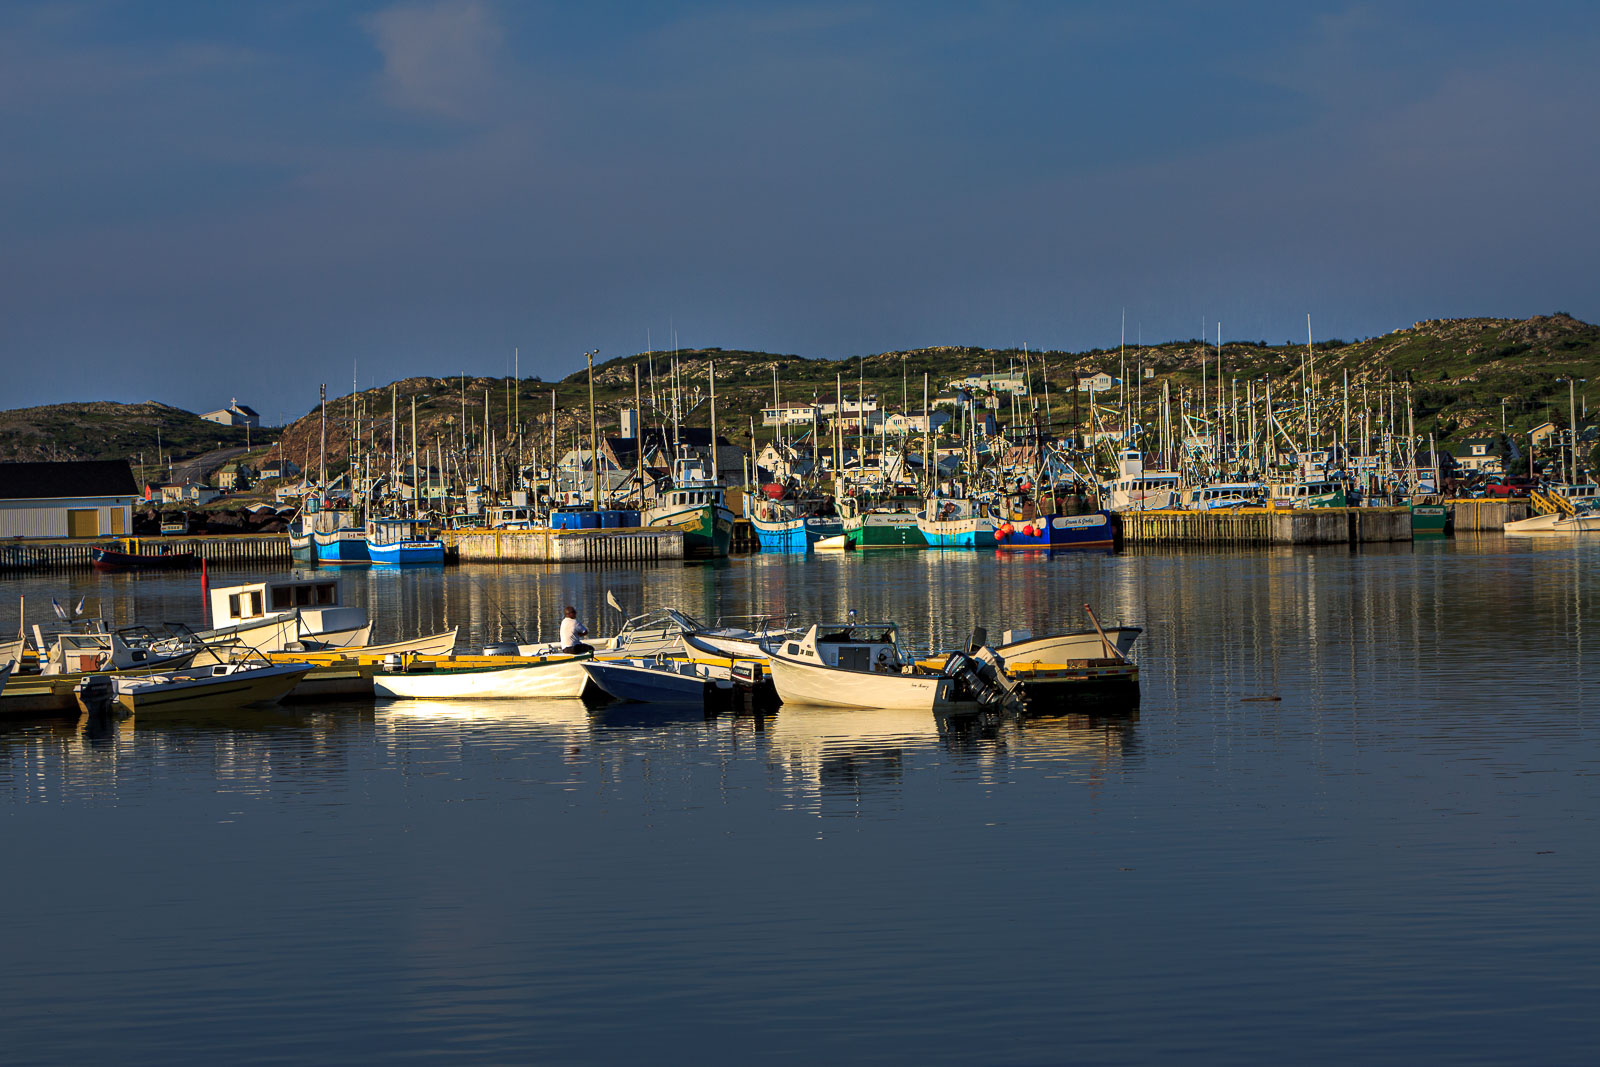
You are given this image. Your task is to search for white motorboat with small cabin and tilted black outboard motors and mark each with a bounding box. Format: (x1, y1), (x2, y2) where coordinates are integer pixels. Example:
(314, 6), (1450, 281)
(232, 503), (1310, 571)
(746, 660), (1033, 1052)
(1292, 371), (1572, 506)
(768, 622), (1010, 712)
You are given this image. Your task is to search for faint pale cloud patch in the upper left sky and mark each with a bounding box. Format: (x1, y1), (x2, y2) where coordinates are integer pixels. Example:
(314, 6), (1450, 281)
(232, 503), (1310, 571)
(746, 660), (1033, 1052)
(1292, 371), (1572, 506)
(362, 0), (501, 120)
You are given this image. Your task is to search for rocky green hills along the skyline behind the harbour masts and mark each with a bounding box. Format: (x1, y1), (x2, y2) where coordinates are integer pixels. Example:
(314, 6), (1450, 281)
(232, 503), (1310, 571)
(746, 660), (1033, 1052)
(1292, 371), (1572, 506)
(0, 314), (1600, 470)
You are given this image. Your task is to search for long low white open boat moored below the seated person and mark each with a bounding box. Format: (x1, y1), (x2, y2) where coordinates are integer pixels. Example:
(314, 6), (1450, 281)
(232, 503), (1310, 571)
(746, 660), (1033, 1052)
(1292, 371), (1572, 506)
(373, 653), (589, 701)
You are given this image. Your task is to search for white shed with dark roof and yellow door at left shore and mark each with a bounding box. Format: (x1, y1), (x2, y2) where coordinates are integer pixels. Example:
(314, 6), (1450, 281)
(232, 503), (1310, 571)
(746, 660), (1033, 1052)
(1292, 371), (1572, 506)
(0, 459), (139, 537)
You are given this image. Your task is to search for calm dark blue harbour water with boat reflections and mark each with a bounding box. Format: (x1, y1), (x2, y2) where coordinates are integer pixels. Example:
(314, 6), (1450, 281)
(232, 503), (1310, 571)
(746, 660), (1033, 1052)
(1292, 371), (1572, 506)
(0, 537), (1600, 1064)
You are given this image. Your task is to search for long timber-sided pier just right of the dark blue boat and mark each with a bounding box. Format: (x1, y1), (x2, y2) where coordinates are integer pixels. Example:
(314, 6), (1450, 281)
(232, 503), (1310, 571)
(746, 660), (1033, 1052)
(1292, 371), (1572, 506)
(1118, 507), (1411, 547)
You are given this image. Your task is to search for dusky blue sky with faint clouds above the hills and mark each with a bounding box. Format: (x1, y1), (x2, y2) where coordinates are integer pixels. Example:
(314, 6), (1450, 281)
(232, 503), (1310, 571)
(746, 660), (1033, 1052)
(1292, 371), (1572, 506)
(0, 0), (1600, 421)
